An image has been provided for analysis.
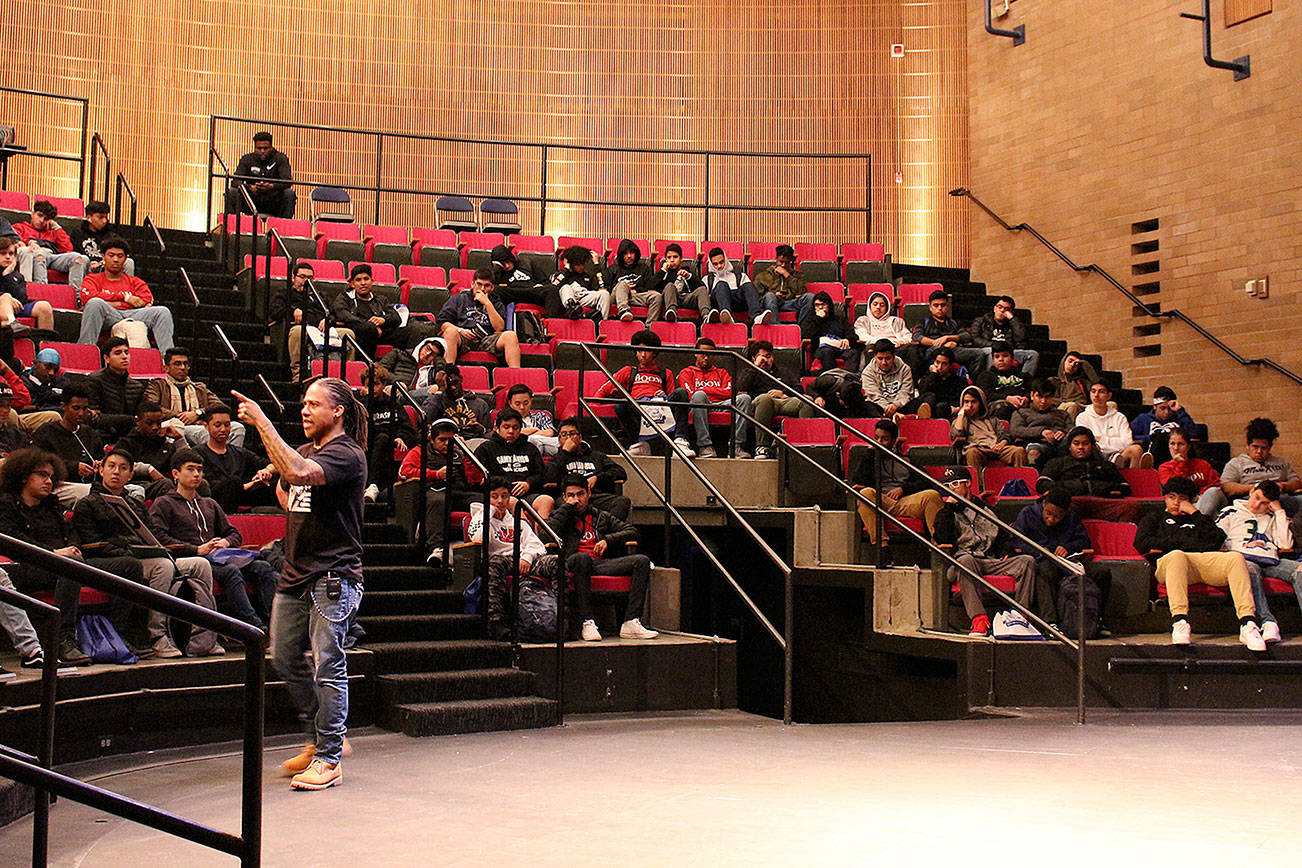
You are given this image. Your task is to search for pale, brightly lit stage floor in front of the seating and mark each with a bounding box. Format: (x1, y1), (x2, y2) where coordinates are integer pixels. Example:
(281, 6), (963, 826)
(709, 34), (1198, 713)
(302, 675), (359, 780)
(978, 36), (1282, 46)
(0, 712), (1302, 868)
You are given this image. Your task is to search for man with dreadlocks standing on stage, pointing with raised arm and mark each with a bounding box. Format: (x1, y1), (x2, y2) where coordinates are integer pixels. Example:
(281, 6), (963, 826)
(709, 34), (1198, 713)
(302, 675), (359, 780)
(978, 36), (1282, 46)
(230, 377), (366, 790)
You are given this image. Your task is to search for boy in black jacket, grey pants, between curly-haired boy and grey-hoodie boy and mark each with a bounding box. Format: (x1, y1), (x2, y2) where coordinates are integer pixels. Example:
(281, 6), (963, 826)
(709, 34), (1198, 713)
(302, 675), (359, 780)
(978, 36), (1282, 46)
(73, 446), (225, 657)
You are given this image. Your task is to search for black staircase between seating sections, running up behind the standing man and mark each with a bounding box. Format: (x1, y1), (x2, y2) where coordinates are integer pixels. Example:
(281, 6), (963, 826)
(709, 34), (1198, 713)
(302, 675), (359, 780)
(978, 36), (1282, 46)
(124, 226), (559, 737)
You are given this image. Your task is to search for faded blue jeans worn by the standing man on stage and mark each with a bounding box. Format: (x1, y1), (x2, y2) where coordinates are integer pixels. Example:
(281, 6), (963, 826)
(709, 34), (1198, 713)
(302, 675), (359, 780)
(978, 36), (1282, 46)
(271, 579), (362, 763)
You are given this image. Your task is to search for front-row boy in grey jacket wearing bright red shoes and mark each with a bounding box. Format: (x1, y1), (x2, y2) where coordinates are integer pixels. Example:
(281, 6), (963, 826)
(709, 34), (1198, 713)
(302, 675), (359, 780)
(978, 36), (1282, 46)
(935, 467), (1035, 636)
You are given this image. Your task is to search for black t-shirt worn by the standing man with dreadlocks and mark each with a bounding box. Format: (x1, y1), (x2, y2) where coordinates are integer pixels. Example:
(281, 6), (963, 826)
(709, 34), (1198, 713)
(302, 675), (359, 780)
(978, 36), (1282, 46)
(280, 435), (366, 592)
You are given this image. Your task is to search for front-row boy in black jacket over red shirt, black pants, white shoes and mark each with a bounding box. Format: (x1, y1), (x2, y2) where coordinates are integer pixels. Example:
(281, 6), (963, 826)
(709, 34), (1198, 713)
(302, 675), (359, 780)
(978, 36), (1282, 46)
(547, 476), (660, 642)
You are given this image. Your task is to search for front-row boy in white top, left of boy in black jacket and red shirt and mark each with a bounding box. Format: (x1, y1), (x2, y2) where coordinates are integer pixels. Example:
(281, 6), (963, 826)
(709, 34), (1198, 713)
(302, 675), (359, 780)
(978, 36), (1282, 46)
(466, 476), (557, 642)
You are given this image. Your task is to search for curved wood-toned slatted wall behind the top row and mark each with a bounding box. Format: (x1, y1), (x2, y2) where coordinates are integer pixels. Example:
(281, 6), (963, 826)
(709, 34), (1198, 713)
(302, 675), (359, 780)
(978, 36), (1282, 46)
(0, 0), (970, 265)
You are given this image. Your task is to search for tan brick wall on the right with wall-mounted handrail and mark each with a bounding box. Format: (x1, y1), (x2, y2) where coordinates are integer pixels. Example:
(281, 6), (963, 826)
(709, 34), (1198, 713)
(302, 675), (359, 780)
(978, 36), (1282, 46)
(967, 0), (1302, 445)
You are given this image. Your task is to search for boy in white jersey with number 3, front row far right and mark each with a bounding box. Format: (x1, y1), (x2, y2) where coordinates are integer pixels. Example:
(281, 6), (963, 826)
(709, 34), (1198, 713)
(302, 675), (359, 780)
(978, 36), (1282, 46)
(1216, 480), (1302, 644)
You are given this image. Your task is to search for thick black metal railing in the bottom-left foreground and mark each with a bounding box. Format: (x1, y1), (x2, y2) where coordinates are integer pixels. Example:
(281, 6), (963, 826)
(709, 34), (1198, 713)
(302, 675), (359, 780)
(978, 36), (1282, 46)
(0, 534), (267, 868)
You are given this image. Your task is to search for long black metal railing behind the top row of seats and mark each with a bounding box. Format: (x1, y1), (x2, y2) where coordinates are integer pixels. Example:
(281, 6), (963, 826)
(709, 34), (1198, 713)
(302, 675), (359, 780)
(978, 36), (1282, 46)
(204, 115), (872, 239)
